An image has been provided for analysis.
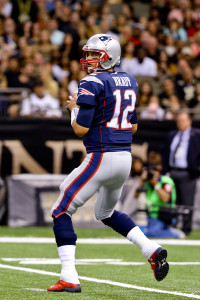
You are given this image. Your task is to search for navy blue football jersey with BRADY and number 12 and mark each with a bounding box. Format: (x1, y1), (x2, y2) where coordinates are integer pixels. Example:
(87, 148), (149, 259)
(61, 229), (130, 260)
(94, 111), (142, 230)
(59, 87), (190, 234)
(77, 71), (138, 153)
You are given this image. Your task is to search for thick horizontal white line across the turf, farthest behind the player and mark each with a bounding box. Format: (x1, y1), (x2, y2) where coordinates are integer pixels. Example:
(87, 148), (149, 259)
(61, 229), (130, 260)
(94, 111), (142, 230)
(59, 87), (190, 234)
(0, 237), (200, 246)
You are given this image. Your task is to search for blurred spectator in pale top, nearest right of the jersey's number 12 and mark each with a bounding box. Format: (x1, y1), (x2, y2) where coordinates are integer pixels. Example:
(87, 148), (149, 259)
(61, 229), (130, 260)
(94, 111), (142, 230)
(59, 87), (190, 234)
(140, 95), (165, 121)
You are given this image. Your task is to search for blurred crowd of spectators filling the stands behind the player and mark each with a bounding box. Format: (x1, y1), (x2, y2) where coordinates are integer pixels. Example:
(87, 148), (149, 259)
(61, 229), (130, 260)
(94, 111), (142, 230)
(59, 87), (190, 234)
(0, 0), (200, 120)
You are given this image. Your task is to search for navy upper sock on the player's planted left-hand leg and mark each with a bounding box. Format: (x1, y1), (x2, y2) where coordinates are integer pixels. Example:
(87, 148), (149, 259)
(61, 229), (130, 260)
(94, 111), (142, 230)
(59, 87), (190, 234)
(53, 214), (77, 247)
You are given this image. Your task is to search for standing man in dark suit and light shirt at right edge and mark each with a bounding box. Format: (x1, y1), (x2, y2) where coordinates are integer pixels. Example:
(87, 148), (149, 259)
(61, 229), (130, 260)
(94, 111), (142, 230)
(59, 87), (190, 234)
(163, 111), (200, 235)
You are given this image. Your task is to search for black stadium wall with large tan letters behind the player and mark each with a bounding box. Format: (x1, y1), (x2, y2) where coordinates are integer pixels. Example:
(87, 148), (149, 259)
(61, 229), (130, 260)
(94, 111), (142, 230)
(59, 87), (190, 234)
(0, 119), (200, 178)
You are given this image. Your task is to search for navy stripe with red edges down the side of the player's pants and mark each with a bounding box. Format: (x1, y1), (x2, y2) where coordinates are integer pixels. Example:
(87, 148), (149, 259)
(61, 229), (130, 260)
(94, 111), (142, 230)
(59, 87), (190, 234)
(52, 152), (103, 218)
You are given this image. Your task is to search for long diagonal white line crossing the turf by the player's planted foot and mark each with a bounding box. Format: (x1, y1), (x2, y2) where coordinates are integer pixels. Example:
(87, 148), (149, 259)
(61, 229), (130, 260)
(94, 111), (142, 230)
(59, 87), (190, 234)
(0, 264), (200, 299)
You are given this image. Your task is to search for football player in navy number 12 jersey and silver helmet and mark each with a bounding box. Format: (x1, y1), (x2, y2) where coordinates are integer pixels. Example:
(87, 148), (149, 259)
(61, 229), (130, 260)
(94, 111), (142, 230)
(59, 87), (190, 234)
(48, 34), (169, 292)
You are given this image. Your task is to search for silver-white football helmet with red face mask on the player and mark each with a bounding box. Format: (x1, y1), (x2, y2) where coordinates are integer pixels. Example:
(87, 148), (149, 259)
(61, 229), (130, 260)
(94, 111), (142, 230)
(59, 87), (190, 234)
(80, 34), (121, 72)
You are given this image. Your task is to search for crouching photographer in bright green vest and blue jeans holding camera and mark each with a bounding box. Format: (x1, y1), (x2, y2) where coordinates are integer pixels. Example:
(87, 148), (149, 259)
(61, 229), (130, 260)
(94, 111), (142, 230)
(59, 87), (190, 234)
(135, 164), (185, 238)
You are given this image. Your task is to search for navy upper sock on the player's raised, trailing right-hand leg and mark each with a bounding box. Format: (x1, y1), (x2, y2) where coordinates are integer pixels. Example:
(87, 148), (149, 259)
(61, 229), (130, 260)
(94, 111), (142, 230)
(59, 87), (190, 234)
(101, 210), (136, 237)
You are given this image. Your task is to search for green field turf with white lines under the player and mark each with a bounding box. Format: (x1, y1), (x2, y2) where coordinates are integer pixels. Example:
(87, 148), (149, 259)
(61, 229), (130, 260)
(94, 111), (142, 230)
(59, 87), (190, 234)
(0, 227), (200, 300)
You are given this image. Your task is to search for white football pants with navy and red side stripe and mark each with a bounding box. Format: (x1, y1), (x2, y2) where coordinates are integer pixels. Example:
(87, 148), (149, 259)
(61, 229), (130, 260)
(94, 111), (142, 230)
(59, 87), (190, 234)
(51, 151), (132, 220)
